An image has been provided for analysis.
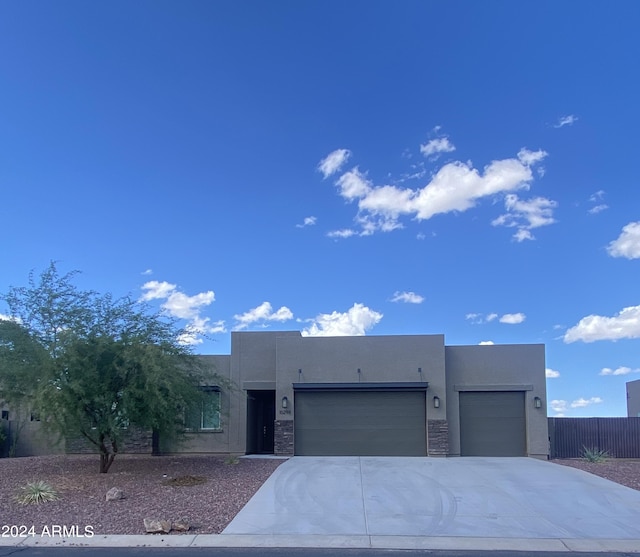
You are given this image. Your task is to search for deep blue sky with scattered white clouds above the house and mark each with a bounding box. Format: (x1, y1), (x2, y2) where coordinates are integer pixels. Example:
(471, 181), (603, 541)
(0, 0), (640, 416)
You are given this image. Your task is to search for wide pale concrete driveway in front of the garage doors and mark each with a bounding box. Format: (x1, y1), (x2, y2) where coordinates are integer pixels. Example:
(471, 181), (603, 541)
(223, 457), (640, 540)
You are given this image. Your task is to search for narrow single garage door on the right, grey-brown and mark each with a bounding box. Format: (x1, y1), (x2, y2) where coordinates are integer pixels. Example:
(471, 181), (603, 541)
(460, 391), (526, 456)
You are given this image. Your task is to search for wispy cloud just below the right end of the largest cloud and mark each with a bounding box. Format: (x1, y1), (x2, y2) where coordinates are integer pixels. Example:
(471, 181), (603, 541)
(491, 194), (558, 242)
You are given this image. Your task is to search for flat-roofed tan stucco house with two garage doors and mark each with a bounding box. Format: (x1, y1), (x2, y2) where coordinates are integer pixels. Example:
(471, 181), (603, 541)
(172, 331), (548, 459)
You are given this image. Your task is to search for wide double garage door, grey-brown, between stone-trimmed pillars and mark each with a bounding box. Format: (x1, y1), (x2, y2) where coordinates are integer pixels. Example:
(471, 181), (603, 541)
(294, 390), (427, 456)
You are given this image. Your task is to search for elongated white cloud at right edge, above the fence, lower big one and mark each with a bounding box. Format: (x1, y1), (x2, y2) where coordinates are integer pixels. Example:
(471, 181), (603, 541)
(564, 306), (640, 343)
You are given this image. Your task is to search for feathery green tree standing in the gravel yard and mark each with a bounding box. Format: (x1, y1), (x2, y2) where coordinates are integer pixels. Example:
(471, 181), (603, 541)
(0, 262), (215, 473)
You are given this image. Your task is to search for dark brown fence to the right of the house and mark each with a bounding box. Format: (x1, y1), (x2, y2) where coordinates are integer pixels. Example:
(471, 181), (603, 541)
(549, 418), (640, 458)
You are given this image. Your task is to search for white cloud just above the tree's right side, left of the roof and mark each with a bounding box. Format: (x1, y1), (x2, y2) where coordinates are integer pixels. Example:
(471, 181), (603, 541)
(140, 280), (221, 345)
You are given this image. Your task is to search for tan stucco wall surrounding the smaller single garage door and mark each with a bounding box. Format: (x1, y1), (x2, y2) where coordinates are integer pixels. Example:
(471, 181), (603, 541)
(445, 344), (549, 459)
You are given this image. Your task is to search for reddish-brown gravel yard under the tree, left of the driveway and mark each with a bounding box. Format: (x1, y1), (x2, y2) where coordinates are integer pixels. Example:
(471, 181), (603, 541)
(0, 455), (283, 534)
